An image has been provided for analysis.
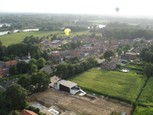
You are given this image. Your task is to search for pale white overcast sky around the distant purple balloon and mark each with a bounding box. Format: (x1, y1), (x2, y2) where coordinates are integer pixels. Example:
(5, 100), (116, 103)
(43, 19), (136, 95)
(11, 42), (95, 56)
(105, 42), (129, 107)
(0, 0), (153, 17)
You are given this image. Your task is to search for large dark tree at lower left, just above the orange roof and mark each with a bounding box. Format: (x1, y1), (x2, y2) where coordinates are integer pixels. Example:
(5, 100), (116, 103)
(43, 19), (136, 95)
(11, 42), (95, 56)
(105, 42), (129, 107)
(6, 84), (27, 109)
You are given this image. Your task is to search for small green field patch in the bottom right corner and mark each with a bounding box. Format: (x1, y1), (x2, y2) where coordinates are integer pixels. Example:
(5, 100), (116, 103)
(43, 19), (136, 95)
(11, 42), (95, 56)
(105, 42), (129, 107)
(133, 107), (153, 115)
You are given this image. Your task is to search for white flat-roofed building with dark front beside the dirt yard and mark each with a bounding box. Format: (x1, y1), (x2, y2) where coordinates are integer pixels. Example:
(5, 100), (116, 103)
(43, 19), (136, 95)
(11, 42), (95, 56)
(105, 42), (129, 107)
(57, 80), (80, 94)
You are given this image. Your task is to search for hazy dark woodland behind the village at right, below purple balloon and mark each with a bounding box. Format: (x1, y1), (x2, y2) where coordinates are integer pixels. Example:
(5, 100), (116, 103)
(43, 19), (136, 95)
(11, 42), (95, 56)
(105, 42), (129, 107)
(95, 23), (153, 39)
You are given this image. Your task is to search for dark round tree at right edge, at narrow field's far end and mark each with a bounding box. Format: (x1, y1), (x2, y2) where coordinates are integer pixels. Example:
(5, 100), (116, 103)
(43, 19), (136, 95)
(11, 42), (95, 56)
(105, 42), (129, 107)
(144, 63), (153, 77)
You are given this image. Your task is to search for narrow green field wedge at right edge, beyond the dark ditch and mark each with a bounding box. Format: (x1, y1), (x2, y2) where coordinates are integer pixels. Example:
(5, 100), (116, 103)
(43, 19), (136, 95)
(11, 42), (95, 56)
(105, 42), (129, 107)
(138, 77), (153, 106)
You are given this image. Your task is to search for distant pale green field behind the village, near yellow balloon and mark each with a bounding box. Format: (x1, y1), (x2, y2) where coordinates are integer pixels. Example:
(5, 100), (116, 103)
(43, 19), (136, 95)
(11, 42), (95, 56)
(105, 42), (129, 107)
(0, 31), (89, 46)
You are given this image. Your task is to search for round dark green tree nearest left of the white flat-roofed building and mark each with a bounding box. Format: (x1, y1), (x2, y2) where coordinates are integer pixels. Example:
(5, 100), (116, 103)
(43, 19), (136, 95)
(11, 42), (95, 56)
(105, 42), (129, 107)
(31, 72), (50, 92)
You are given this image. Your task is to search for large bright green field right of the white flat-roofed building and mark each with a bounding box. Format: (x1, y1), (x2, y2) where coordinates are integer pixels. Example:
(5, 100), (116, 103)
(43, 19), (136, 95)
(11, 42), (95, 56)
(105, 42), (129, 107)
(70, 68), (146, 102)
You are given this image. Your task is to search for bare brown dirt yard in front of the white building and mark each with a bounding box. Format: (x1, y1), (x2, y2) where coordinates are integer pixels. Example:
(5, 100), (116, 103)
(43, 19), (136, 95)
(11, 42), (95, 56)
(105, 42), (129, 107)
(29, 89), (132, 115)
